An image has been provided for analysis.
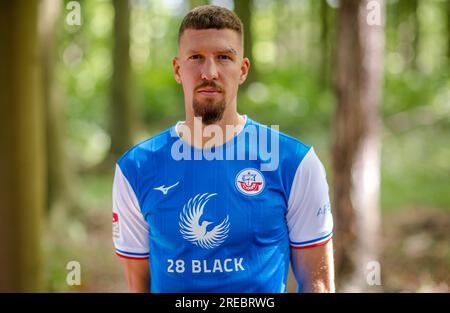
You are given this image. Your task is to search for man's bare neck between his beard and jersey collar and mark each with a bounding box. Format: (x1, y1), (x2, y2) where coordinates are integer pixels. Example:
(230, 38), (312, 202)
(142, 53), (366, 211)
(181, 111), (246, 149)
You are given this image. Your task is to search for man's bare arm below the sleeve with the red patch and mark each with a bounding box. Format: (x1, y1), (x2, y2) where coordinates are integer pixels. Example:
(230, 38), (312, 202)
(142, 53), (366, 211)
(121, 258), (150, 292)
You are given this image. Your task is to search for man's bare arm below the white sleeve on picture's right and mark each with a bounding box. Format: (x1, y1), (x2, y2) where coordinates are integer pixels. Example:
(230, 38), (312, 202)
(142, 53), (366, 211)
(291, 240), (335, 292)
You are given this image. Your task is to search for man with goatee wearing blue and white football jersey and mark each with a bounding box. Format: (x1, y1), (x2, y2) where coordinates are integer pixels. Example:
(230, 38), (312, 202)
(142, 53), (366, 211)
(113, 5), (334, 292)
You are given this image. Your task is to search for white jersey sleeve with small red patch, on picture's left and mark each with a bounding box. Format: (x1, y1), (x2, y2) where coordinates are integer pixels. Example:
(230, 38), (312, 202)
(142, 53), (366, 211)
(112, 165), (149, 259)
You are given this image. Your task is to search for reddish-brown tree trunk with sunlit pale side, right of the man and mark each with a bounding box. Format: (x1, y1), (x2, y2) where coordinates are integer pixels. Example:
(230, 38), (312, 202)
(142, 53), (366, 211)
(333, 0), (384, 290)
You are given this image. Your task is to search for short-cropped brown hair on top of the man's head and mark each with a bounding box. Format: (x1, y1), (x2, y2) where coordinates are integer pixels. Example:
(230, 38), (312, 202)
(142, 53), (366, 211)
(178, 5), (244, 42)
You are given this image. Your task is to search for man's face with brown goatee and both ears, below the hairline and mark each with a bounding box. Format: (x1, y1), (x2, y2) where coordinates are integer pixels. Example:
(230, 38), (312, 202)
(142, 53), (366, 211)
(172, 29), (250, 125)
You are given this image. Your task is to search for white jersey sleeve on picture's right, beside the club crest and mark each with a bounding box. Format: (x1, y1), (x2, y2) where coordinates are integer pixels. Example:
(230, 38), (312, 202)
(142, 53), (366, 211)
(286, 148), (333, 249)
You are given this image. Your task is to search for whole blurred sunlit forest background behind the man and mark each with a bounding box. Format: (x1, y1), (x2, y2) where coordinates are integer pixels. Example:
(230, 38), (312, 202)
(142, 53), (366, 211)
(0, 0), (450, 292)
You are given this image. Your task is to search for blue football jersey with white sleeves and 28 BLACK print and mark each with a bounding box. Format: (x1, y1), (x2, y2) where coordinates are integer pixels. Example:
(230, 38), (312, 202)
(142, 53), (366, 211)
(113, 116), (333, 292)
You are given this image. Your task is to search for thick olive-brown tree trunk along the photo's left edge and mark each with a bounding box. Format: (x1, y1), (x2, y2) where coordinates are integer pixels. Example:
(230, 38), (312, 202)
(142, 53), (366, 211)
(0, 0), (45, 292)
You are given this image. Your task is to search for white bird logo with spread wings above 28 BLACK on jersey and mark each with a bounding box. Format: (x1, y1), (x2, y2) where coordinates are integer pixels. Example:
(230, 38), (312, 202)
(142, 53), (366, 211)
(178, 193), (230, 249)
